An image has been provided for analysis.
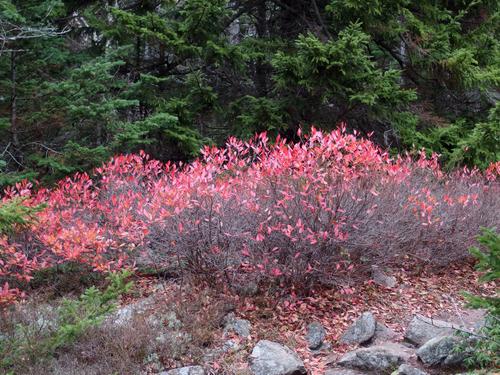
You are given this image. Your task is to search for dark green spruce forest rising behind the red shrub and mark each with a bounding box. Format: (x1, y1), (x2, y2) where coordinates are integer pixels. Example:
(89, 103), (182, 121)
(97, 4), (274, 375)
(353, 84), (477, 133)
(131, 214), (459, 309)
(0, 0), (500, 186)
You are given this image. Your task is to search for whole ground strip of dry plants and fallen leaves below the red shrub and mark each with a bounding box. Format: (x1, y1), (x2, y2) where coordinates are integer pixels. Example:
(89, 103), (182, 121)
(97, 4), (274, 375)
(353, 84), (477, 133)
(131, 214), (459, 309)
(0, 266), (494, 375)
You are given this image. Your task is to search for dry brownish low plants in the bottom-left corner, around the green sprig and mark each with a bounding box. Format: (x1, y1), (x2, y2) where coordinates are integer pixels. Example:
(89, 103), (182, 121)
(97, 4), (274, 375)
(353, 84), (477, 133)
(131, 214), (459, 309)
(0, 274), (245, 375)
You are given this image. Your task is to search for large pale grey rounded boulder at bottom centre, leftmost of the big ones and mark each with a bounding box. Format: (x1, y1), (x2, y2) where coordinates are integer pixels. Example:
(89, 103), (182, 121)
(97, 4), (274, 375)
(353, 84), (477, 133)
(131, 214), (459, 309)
(250, 340), (307, 375)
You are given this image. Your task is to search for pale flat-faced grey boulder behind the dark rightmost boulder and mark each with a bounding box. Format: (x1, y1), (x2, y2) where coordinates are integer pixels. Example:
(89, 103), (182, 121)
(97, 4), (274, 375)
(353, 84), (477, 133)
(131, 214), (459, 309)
(405, 314), (453, 346)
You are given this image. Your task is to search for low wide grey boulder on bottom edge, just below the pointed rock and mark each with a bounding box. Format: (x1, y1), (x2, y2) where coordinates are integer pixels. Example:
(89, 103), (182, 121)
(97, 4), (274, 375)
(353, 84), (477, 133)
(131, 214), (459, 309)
(337, 343), (411, 374)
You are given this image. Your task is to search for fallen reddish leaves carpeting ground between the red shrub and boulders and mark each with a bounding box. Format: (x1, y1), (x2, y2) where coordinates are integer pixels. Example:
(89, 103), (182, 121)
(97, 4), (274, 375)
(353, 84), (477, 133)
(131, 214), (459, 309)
(123, 265), (496, 375)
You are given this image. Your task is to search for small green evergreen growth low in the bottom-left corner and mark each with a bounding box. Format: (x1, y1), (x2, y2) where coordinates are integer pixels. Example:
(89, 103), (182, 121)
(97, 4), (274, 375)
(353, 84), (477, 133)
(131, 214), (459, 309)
(0, 271), (132, 373)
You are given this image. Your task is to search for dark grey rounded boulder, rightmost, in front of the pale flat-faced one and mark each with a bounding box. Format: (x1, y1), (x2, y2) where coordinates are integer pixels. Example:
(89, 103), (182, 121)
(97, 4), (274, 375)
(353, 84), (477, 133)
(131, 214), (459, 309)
(417, 336), (465, 366)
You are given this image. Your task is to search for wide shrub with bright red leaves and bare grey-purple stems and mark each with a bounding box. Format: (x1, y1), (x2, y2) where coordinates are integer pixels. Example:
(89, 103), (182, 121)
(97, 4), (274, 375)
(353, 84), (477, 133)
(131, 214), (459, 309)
(0, 129), (500, 304)
